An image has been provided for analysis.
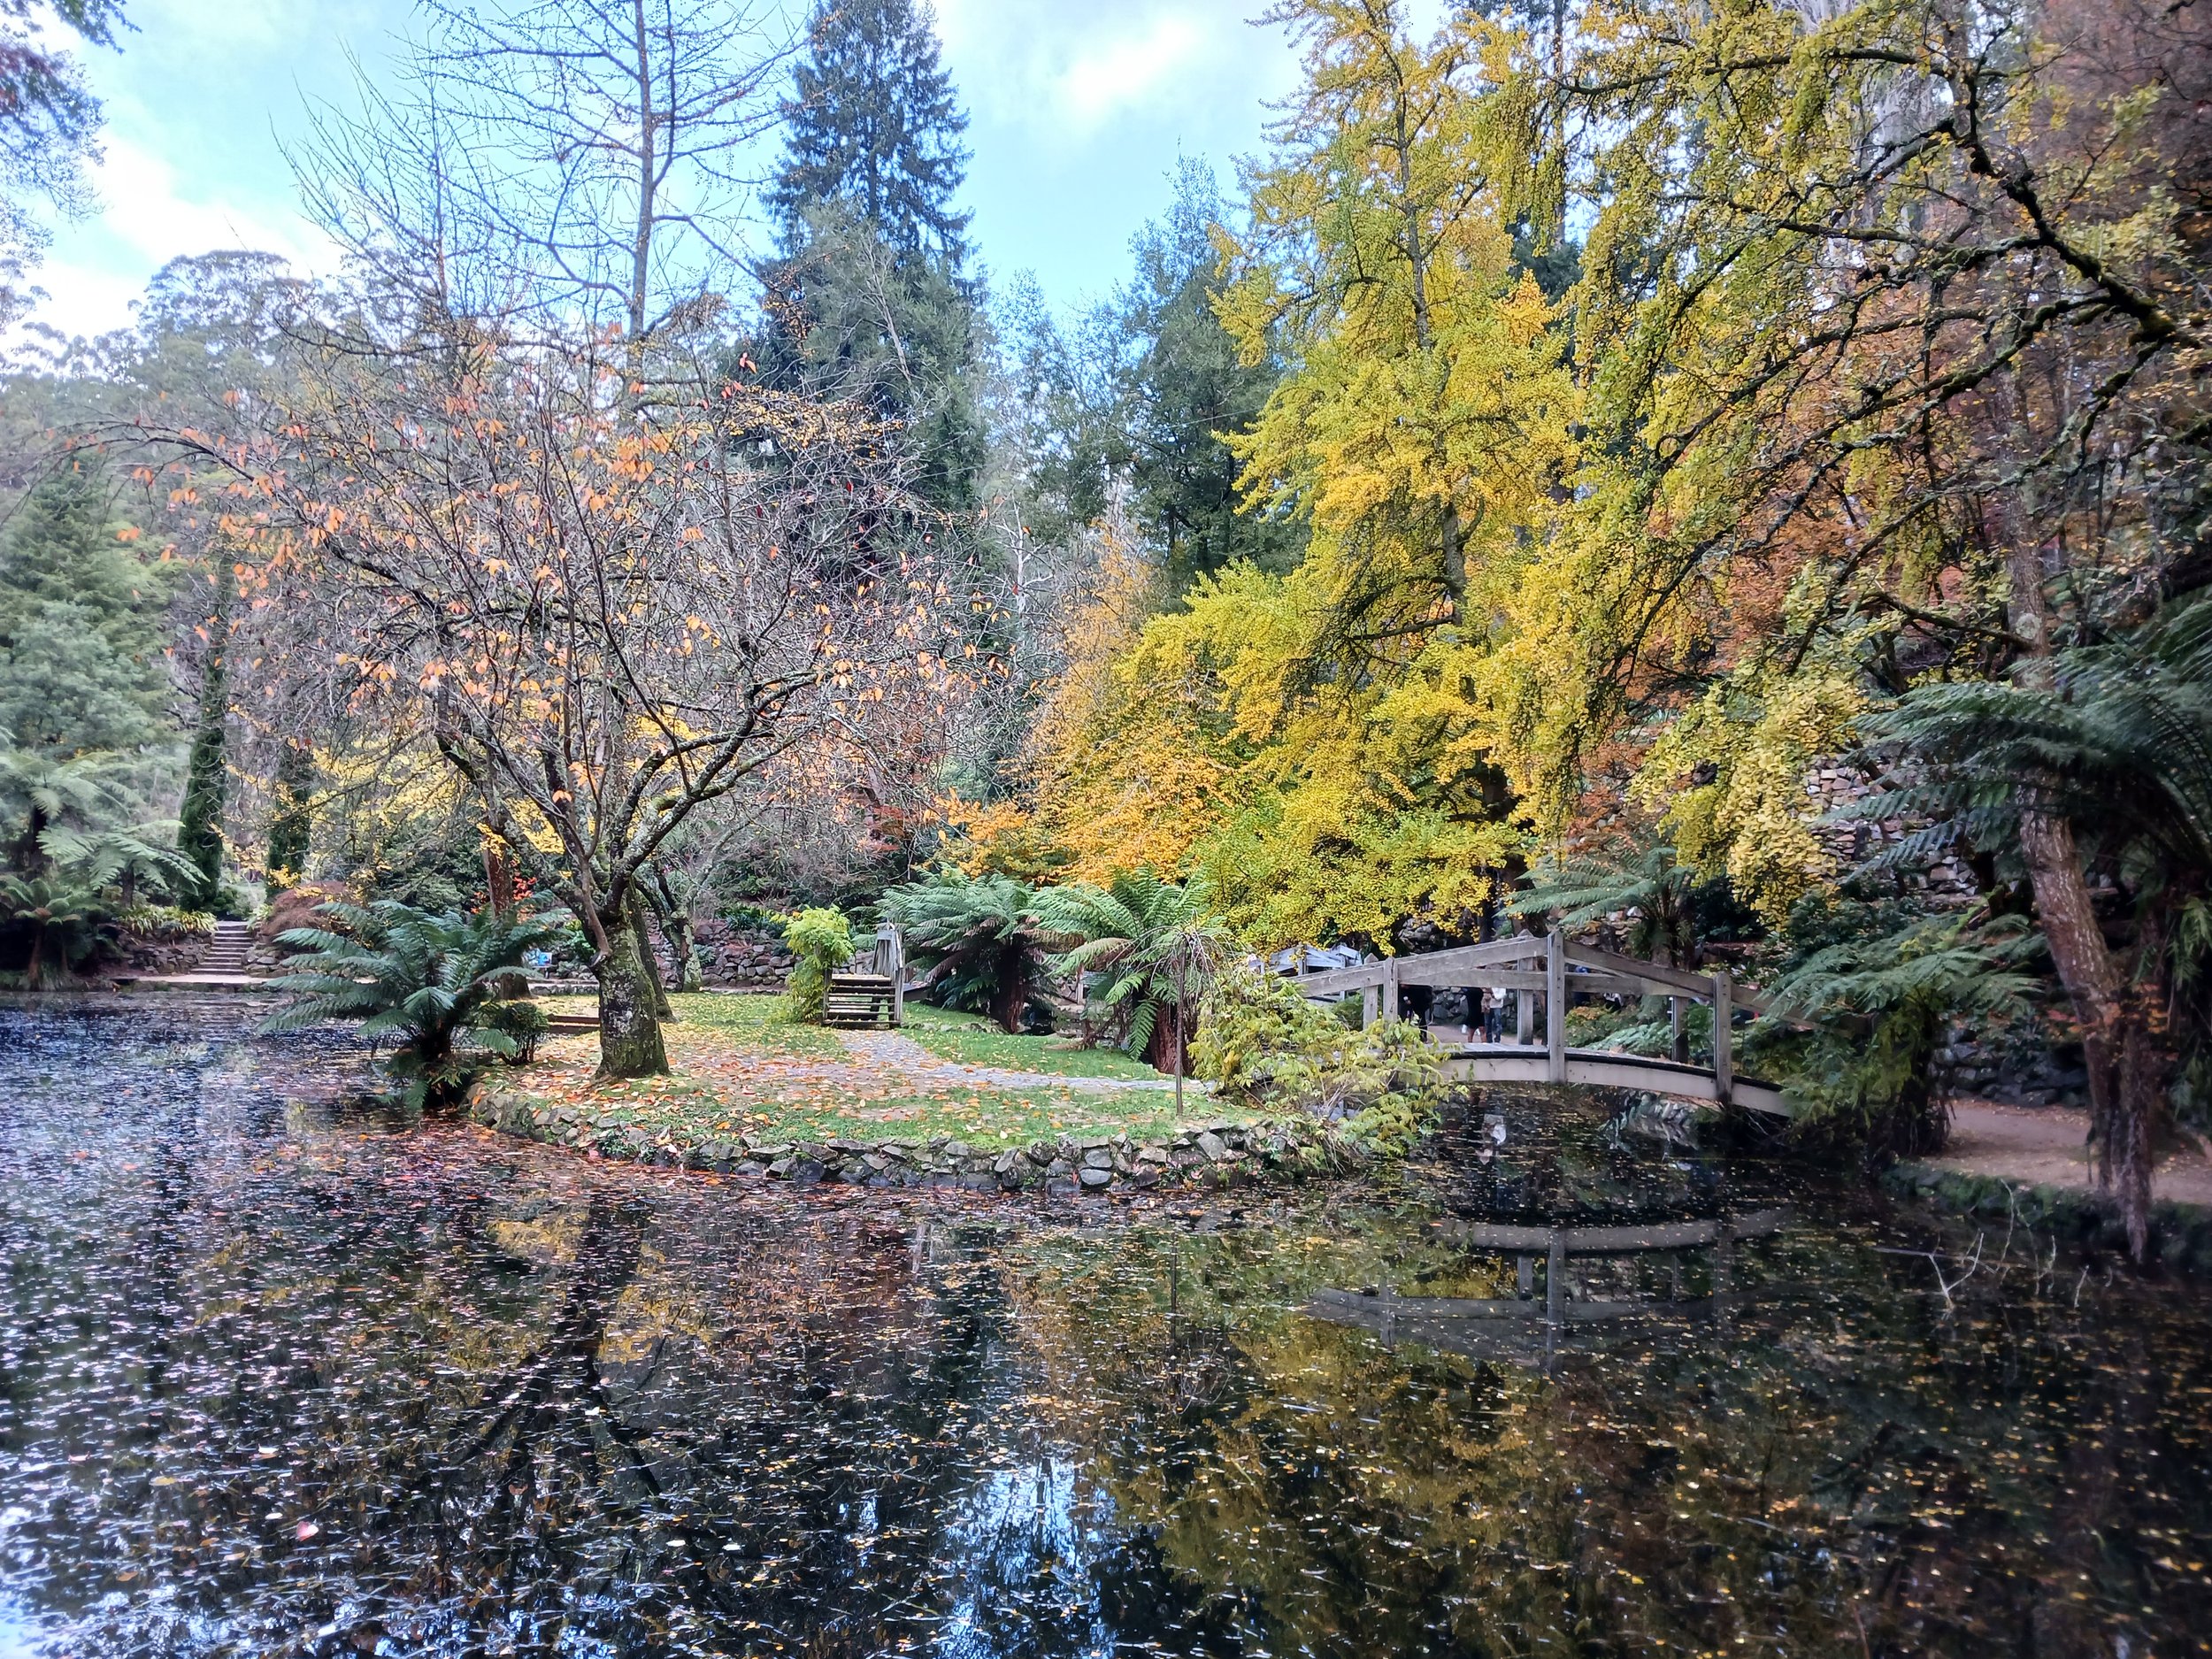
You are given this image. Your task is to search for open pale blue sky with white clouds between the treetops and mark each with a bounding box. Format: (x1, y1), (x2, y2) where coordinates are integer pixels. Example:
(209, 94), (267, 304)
(12, 0), (1299, 345)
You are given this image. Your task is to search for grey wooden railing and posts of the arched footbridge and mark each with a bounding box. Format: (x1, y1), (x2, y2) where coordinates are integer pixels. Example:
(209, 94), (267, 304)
(1292, 932), (1765, 1100)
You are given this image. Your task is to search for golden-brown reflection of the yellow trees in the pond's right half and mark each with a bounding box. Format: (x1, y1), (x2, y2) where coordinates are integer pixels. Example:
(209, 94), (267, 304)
(1004, 1225), (2212, 1655)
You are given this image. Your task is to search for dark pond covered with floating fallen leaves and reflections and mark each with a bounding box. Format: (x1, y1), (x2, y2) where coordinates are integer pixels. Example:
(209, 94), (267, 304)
(0, 1002), (2212, 1659)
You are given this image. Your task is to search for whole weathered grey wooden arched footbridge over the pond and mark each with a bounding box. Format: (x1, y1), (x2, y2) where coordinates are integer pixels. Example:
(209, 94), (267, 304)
(1296, 933), (1790, 1118)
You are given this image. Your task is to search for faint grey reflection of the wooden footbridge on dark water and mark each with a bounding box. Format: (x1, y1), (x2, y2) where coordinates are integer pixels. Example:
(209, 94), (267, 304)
(1305, 1210), (1790, 1365)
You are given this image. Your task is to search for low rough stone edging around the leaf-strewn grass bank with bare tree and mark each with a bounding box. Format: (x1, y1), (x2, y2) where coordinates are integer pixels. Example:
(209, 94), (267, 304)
(469, 1091), (1354, 1197)
